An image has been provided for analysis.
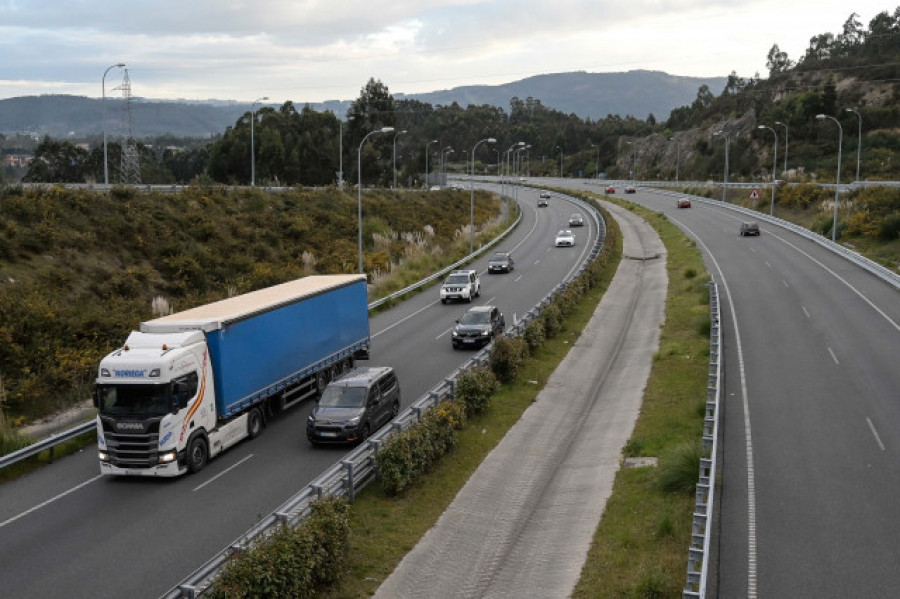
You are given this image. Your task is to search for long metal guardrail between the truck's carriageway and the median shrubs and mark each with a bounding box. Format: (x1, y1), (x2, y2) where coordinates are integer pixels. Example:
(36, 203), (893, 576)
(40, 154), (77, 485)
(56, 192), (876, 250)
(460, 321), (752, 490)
(161, 191), (606, 599)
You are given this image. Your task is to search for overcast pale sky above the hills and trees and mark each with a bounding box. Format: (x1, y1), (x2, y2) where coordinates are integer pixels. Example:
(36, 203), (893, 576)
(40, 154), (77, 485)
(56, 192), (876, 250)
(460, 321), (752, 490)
(0, 0), (897, 103)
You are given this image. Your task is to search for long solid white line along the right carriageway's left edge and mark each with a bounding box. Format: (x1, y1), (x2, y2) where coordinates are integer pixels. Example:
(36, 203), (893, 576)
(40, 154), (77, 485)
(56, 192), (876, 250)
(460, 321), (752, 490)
(672, 218), (757, 599)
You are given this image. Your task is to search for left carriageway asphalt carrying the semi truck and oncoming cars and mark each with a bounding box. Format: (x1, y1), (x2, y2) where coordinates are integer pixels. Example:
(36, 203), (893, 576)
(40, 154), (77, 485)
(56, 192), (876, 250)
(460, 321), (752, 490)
(0, 185), (597, 599)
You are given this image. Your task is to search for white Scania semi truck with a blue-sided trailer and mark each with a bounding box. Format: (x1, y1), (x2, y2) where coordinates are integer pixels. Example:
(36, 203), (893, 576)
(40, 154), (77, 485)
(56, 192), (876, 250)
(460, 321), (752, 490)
(94, 275), (370, 477)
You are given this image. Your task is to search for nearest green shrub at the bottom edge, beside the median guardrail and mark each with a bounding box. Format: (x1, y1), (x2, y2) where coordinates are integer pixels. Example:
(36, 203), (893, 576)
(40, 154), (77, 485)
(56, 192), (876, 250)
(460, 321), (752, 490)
(210, 498), (350, 599)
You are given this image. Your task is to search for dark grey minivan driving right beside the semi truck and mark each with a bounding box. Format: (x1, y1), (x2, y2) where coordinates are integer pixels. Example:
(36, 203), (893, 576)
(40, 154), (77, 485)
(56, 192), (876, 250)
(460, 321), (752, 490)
(306, 366), (400, 445)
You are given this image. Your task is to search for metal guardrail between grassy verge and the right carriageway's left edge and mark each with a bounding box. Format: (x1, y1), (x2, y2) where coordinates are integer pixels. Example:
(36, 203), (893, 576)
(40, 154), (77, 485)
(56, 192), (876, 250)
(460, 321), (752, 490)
(682, 281), (724, 599)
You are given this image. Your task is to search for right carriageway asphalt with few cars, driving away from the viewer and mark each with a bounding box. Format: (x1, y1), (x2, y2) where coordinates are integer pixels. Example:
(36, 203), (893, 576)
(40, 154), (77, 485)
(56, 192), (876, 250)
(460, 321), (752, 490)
(546, 179), (900, 599)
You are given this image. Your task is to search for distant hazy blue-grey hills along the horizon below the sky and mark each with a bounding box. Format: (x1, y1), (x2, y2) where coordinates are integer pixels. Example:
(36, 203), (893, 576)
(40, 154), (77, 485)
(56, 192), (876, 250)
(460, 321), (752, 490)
(0, 71), (727, 139)
